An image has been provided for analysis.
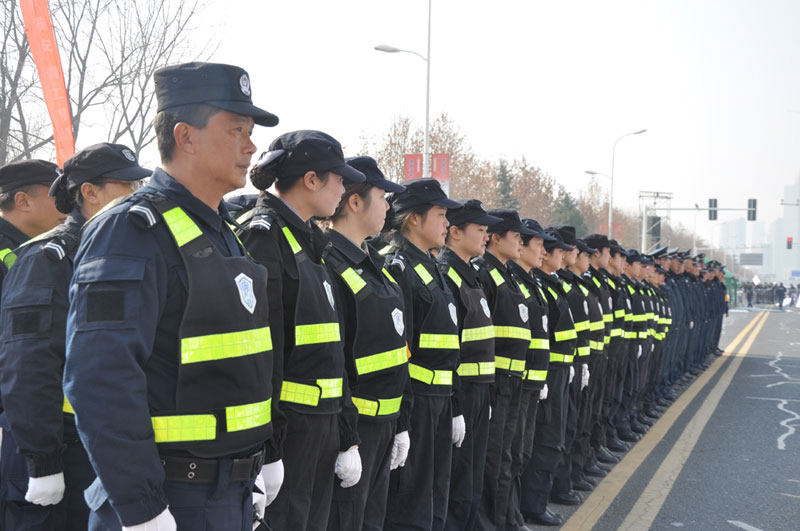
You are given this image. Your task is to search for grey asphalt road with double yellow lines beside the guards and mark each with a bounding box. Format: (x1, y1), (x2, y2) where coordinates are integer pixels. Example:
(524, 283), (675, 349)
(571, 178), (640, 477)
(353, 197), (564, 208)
(529, 309), (800, 531)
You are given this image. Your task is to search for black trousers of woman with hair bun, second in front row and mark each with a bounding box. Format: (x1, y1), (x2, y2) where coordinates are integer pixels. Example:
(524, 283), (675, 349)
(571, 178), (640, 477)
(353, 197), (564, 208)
(266, 408), (339, 531)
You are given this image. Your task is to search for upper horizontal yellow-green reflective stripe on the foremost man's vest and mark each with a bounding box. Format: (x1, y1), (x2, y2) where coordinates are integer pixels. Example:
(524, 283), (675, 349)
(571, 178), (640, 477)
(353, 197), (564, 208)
(181, 326), (272, 364)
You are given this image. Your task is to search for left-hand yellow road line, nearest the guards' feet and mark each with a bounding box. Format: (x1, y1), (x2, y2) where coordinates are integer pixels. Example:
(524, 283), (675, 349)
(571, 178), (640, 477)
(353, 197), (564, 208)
(561, 312), (765, 531)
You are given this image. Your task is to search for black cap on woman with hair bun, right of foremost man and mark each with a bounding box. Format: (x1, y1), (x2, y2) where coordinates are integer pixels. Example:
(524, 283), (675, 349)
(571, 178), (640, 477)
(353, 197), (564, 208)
(256, 130), (366, 183)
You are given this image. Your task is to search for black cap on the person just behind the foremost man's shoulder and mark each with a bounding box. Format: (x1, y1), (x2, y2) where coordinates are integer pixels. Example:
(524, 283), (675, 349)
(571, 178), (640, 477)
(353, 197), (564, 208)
(50, 142), (153, 196)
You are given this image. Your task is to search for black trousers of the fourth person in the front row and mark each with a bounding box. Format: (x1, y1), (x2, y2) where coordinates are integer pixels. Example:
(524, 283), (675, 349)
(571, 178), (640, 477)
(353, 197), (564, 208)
(383, 394), (453, 531)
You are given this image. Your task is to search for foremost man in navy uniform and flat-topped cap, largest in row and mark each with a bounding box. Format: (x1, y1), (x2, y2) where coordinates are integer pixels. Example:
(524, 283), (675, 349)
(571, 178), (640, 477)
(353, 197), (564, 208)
(64, 63), (280, 530)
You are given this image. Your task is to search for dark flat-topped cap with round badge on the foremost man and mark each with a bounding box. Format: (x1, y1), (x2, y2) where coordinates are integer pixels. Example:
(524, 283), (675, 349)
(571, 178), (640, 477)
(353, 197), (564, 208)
(153, 63), (278, 127)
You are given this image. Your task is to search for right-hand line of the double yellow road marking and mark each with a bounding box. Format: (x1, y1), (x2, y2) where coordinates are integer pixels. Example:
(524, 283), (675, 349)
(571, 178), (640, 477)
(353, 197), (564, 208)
(619, 313), (769, 531)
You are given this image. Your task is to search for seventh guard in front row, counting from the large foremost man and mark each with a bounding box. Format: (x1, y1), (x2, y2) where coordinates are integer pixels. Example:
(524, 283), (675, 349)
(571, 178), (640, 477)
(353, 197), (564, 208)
(506, 219), (554, 529)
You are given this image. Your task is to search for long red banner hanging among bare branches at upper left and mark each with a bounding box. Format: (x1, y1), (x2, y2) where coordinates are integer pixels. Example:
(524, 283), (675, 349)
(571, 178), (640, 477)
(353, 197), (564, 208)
(19, 0), (75, 167)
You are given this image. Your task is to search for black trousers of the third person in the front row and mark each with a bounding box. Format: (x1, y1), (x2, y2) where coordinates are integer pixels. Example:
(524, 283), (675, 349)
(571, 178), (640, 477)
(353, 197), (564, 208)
(328, 417), (397, 531)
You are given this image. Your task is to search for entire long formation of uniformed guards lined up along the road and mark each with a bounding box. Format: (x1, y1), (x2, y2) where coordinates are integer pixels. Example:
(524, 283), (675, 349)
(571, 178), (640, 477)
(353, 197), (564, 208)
(0, 63), (727, 531)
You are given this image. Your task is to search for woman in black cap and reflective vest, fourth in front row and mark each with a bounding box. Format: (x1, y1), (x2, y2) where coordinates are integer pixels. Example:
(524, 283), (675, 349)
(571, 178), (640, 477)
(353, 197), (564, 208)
(384, 179), (464, 530)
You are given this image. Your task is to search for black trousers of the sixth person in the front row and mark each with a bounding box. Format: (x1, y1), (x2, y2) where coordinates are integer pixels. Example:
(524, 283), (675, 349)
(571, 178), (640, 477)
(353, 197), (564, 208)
(477, 372), (522, 529)
